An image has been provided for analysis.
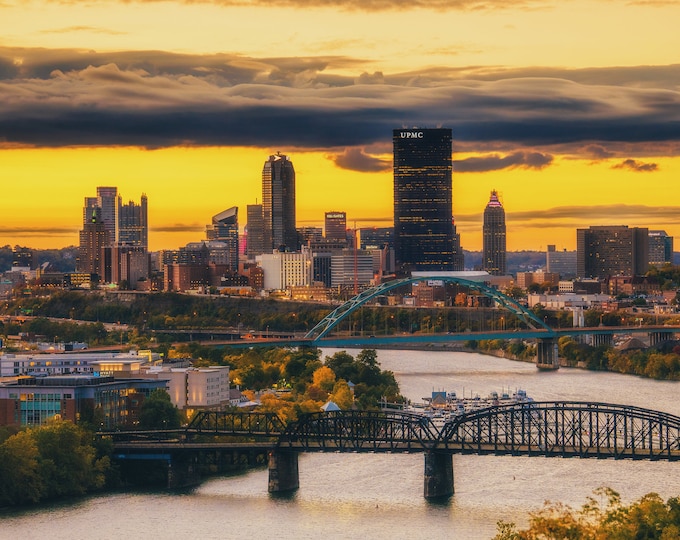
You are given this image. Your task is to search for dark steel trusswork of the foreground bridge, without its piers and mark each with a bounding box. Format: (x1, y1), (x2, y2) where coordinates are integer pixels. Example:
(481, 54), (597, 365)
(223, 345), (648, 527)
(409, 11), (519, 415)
(177, 401), (680, 461)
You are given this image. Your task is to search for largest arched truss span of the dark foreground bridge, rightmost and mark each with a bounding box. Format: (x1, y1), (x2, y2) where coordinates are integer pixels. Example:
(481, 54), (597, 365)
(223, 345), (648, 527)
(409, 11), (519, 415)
(438, 402), (680, 460)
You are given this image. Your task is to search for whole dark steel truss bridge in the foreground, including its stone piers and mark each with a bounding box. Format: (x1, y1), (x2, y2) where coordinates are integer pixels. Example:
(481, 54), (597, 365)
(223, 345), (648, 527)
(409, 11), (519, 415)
(109, 401), (680, 499)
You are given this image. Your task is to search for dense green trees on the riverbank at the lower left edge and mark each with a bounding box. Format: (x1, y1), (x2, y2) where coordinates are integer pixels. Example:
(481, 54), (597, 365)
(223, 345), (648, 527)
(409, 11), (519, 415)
(0, 420), (113, 506)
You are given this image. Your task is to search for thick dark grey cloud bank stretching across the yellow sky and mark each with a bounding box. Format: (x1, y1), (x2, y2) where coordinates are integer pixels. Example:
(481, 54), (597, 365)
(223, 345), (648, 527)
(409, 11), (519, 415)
(0, 48), (680, 154)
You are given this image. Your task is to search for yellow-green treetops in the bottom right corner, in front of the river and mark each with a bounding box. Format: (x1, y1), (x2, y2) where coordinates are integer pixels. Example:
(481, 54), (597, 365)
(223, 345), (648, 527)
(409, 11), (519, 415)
(494, 488), (680, 540)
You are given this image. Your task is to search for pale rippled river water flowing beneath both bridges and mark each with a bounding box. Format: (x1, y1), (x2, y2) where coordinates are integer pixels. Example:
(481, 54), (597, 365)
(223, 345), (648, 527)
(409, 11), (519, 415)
(0, 350), (680, 540)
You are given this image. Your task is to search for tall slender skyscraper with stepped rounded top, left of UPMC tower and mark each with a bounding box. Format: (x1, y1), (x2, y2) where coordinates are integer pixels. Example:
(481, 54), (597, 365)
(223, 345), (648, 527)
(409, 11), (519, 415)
(262, 152), (299, 251)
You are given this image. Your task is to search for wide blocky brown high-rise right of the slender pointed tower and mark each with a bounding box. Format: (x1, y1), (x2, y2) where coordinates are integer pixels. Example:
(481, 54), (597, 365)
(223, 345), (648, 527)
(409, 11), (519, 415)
(576, 225), (649, 279)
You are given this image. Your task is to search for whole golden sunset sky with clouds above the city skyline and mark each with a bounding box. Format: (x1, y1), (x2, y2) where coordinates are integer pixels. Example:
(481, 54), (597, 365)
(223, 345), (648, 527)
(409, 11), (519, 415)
(0, 0), (680, 254)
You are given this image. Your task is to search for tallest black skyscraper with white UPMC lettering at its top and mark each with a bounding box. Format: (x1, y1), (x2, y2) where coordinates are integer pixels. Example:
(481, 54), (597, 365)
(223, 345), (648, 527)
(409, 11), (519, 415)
(393, 129), (458, 272)
